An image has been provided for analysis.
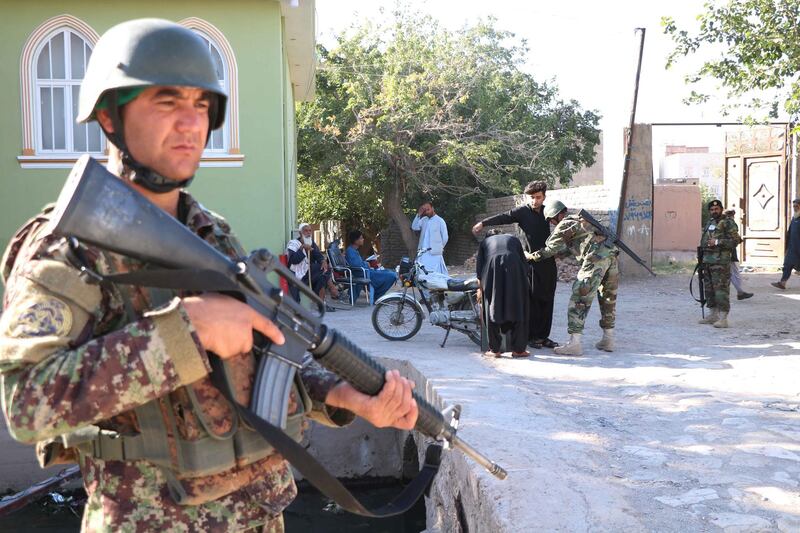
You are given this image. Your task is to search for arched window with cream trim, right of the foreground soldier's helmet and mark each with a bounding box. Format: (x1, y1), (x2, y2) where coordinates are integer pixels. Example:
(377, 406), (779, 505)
(179, 17), (242, 165)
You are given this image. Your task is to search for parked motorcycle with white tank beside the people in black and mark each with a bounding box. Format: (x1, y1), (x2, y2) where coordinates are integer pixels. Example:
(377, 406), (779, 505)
(372, 250), (481, 348)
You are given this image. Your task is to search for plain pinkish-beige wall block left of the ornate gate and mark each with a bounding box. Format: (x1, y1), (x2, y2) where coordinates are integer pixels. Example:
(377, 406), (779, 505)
(653, 185), (701, 251)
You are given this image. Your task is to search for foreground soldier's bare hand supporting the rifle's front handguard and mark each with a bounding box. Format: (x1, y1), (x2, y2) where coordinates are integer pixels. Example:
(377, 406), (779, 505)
(325, 370), (419, 429)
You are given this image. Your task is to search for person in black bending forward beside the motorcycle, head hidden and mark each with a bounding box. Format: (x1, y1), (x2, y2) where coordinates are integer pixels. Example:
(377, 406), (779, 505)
(476, 230), (530, 357)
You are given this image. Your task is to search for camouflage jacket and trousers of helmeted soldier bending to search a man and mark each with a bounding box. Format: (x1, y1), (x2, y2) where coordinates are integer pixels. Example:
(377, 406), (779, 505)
(533, 215), (619, 334)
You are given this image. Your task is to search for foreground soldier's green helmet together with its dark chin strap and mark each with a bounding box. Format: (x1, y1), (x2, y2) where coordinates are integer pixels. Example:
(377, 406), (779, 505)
(77, 19), (228, 193)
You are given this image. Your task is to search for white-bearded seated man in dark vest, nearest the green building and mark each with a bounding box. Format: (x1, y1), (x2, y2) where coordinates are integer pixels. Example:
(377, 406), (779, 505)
(286, 223), (339, 312)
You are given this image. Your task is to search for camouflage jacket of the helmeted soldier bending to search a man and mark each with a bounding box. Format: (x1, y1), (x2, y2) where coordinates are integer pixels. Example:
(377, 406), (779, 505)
(533, 215), (619, 262)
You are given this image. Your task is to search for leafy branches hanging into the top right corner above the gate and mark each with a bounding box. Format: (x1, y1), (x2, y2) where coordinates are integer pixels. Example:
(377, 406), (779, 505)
(661, 0), (800, 120)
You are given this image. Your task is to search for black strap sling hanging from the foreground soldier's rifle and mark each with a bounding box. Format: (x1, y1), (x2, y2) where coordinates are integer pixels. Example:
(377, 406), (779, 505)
(94, 269), (442, 518)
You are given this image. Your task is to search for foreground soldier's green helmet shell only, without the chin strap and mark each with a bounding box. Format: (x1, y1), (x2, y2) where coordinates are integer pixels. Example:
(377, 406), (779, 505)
(77, 19), (228, 131)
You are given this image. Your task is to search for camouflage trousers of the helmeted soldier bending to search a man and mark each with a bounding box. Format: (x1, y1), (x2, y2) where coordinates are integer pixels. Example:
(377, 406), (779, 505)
(567, 255), (619, 333)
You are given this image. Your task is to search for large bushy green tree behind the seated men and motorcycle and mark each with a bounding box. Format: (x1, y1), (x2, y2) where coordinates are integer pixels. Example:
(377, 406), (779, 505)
(297, 9), (599, 253)
